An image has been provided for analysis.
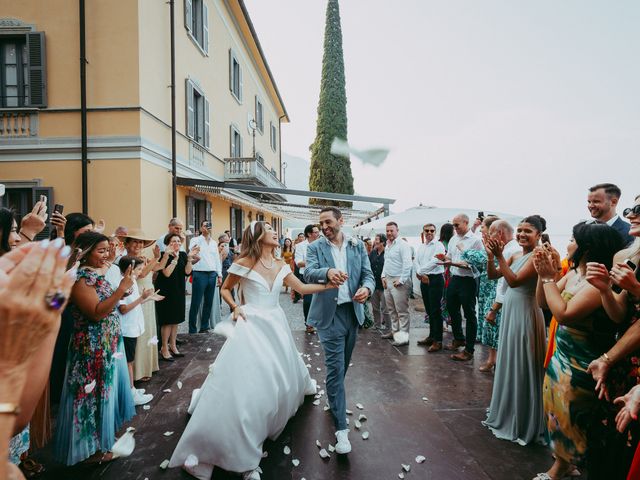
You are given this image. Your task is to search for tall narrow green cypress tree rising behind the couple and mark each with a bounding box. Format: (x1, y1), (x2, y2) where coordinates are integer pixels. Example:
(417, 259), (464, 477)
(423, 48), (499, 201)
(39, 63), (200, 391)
(309, 0), (353, 207)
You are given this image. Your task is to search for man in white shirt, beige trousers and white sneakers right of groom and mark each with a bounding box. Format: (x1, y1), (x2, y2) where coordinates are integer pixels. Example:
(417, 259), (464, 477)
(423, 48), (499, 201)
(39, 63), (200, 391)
(381, 222), (413, 347)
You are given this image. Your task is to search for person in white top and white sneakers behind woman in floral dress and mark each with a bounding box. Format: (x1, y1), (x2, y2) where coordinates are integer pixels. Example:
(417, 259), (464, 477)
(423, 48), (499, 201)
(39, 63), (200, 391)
(118, 256), (157, 405)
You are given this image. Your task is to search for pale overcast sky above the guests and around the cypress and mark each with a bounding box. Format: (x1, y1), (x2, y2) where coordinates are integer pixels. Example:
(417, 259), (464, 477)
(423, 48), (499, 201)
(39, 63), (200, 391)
(245, 0), (640, 234)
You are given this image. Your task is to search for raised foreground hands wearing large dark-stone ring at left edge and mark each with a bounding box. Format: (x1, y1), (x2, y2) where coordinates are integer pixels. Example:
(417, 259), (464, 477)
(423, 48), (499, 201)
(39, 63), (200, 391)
(0, 242), (75, 479)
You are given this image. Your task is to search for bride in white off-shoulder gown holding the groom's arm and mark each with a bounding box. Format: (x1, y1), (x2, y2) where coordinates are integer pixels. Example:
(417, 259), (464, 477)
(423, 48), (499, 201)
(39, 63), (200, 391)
(169, 222), (335, 480)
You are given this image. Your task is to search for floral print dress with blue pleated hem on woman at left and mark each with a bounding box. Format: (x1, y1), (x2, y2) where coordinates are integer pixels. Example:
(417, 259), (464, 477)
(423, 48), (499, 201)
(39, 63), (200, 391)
(54, 268), (135, 465)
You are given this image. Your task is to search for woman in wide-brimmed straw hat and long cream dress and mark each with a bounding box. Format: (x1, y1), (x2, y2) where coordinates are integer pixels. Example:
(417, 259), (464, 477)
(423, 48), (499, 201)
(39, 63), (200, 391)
(121, 229), (169, 382)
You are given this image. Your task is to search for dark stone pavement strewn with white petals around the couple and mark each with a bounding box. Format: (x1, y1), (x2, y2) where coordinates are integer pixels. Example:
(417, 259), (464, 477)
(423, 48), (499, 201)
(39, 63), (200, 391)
(39, 294), (552, 480)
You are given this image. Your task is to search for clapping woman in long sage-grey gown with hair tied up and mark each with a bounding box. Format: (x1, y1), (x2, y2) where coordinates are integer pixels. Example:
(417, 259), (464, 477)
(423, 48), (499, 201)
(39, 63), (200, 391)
(483, 215), (546, 445)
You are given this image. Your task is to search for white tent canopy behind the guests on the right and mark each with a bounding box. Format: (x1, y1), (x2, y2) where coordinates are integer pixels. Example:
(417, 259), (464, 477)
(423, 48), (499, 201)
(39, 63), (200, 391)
(353, 205), (524, 238)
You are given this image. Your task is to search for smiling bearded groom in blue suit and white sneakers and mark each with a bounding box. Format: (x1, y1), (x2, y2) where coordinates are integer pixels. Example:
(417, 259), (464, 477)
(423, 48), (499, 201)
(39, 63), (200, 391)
(304, 207), (375, 454)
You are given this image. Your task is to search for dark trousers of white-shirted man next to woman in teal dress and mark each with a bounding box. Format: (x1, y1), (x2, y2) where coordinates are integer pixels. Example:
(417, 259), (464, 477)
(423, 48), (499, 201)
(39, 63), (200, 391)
(447, 275), (478, 353)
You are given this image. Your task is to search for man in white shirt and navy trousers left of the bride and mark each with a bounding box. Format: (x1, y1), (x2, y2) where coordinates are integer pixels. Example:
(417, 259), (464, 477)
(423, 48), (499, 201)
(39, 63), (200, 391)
(189, 220), (222, 333)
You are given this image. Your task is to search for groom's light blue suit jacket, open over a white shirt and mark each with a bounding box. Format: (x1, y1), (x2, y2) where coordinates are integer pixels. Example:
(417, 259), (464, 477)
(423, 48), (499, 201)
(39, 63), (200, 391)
(304, 238), (376, 330)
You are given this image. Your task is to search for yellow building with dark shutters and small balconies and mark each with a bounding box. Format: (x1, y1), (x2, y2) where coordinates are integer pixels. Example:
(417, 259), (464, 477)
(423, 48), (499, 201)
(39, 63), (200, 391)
(0, 0), (289, 237)
